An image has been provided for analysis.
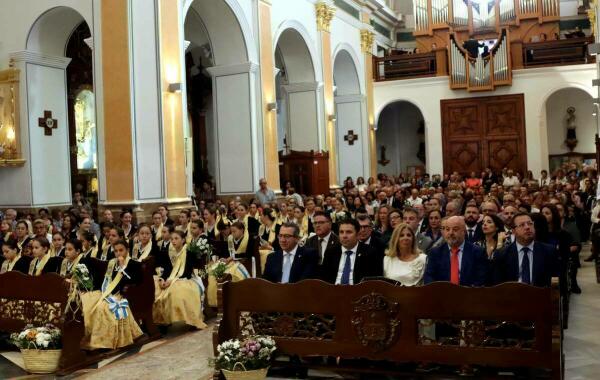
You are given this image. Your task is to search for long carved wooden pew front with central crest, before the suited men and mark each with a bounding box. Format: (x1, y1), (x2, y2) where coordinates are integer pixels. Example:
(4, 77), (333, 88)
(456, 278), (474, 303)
(213, 279), (563, 379)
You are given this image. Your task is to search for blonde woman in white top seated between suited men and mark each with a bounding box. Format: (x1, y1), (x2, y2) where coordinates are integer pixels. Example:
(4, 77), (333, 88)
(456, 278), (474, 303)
(383, 223), (427, 286)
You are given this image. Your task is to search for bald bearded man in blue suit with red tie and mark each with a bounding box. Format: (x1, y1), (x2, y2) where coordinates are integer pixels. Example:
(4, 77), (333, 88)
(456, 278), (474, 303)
(424, 216), (488, 286)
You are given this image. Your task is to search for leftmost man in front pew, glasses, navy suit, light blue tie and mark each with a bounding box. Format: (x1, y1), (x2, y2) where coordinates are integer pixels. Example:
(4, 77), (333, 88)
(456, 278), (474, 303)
(263, 223), (318, 284)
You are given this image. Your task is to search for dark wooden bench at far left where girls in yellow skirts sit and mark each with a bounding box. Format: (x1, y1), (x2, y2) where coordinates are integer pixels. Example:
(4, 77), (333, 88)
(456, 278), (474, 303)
(0, 259), (159, 375)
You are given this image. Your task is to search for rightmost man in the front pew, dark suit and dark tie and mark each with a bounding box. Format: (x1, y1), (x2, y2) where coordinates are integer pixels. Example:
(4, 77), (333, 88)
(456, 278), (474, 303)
(493, 213), (558, 287)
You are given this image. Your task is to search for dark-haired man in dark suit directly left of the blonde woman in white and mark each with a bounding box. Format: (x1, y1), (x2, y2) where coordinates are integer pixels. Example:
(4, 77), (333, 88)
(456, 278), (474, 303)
(321, 219), (383, 285)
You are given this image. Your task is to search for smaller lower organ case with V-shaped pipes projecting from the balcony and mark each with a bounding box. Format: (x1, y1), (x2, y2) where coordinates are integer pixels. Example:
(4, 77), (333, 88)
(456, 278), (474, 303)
(449, 29), (512, 91)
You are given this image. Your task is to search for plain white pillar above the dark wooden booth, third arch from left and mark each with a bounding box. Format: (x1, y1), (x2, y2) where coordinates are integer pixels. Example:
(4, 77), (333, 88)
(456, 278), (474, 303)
(281, 82), (322, 151)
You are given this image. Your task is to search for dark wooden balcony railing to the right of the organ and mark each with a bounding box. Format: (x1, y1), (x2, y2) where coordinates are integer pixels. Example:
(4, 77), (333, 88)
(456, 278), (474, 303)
(523, 37), (594, 68)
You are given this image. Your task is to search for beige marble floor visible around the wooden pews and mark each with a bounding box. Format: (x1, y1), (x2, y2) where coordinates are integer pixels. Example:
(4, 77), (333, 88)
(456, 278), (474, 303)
(0, 253), (600, 380)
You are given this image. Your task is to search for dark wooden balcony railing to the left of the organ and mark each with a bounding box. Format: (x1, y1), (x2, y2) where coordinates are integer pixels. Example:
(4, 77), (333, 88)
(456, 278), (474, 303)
(373, 52), (437, 82)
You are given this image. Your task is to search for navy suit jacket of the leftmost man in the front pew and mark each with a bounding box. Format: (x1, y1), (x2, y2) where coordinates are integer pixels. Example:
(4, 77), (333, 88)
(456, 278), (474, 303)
(262, 246), (319, 283)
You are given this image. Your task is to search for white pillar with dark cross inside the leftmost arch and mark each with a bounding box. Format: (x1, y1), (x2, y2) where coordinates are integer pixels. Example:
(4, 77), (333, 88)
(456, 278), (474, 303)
(0, 51), (72, 207)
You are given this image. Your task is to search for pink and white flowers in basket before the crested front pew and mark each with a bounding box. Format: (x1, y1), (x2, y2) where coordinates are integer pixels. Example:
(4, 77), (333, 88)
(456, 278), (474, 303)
(212, 335), (277, 371)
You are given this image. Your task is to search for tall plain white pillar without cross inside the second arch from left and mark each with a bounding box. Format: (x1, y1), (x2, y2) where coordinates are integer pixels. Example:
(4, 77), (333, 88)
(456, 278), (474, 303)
(207, 62), (261, 195)
